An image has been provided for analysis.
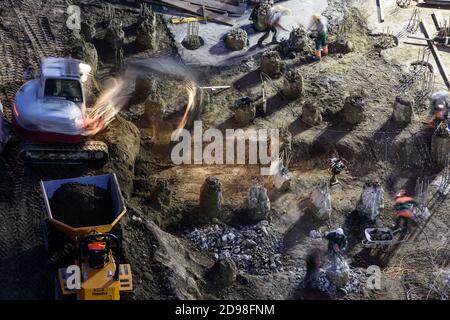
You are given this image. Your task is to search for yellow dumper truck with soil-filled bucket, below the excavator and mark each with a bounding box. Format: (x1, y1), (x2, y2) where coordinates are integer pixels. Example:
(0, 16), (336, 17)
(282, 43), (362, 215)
(41, 174), (133, 300)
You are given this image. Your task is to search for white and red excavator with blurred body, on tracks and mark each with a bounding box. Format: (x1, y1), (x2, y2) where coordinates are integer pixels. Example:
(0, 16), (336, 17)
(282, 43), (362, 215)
(12, 57), (108, 164)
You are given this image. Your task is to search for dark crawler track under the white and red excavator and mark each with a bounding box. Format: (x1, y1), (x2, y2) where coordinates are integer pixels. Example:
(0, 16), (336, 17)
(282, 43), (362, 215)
(19, 141), (108, 165)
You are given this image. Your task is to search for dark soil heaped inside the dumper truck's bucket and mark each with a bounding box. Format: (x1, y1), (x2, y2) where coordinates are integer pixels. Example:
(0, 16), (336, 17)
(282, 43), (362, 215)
(50, 183), (113, 228)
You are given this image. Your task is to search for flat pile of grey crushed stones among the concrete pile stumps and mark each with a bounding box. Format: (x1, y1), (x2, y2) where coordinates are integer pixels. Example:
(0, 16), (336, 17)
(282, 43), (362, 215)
(186, 220), (283, 275)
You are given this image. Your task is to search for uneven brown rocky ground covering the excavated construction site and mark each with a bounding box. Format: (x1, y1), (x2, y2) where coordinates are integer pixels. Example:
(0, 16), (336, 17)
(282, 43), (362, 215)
(0, 0), (450, 299)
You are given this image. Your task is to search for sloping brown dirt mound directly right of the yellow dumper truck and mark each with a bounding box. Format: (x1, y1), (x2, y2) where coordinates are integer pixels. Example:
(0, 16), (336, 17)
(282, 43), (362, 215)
(123, 207), (213, 299)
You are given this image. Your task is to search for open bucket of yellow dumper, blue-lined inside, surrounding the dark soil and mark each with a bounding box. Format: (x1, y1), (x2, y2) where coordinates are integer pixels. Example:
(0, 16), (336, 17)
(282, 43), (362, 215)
(41, 173), (126, 237)
